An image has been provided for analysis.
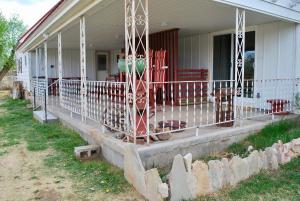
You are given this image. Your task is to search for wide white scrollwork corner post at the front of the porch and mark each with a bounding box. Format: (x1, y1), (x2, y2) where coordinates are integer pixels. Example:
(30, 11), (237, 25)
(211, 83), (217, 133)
(125, 0), (149, 143)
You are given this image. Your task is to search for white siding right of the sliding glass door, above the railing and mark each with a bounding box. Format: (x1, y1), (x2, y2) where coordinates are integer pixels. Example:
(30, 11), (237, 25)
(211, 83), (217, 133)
(255, 22), (296, 79)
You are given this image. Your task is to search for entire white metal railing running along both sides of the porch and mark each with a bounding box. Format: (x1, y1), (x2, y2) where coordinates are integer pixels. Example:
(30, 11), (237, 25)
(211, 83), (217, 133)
(36, 79), (299, 143)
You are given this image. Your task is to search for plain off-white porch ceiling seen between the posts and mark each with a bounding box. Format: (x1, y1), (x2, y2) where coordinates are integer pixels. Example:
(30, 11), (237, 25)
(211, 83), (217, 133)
(49, 0), (279, 50)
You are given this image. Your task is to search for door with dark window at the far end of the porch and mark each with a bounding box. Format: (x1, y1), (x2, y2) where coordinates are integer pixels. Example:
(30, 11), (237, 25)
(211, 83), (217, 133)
(96, 52), (109, 81)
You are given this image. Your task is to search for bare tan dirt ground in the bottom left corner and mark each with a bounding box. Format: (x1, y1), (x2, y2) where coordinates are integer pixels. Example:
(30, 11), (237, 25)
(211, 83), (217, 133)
(0, 143), (142, 201)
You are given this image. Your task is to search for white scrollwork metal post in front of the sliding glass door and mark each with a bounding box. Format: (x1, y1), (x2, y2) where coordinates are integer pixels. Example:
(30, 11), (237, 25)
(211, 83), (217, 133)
(234, 8), (245, 124)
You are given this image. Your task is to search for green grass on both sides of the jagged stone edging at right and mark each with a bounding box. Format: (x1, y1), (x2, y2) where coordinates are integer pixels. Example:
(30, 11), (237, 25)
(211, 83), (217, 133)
(196, 120), (300, 201)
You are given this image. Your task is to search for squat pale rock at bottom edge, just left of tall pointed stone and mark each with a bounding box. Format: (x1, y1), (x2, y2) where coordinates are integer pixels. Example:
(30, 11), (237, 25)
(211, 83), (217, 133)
(145, 168), (164, 201)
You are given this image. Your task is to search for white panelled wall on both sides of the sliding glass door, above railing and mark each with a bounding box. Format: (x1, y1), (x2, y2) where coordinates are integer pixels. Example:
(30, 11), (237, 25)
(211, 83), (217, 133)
(179, 22), (300, 79)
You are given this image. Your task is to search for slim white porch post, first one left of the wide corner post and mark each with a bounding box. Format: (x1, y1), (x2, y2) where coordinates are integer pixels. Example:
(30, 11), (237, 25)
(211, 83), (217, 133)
(80, 16), (87, 122)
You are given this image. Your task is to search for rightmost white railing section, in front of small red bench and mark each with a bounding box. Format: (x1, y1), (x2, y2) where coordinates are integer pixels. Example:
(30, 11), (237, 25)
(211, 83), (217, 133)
(242, 79), (298, 119)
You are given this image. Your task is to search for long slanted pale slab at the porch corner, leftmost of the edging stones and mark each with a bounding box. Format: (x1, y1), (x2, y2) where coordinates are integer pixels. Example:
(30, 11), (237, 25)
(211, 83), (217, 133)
(124, 144), (147, 197)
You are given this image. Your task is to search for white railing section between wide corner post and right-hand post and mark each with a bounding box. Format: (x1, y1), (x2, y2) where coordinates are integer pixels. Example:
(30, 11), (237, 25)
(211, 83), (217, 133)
(150, 80), (235, 135)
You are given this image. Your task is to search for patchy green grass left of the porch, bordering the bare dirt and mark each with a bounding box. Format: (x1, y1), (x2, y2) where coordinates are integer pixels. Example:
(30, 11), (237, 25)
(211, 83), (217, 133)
(0, 96), (129, 193)
